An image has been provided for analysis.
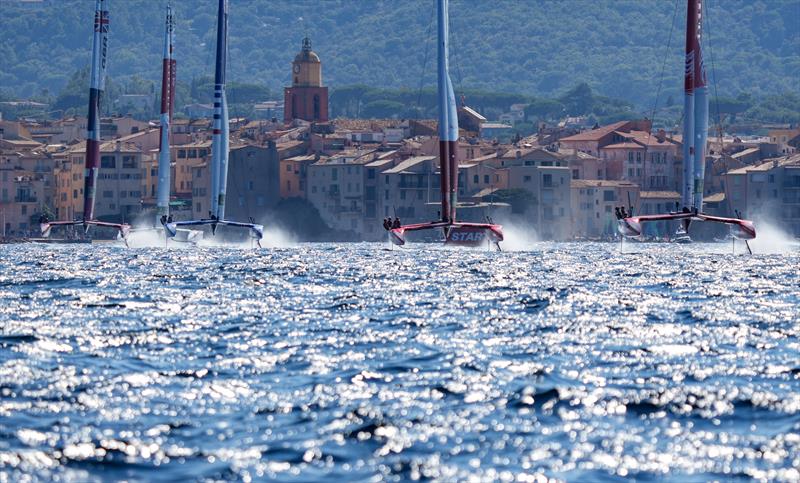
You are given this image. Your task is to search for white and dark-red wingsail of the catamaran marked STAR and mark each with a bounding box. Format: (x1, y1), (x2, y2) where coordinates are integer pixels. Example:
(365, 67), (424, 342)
(437, 0), (458, 222)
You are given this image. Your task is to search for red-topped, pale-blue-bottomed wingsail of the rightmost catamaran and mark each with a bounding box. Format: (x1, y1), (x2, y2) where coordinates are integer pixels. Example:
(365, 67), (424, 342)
(682, 0), (708, 211)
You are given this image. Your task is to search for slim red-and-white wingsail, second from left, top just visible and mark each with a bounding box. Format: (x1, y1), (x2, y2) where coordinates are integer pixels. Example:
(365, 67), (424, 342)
(156, 5), (175, 221)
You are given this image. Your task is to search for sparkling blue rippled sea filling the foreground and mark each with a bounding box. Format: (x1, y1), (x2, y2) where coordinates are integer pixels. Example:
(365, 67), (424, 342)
(0, 243), (800, 481)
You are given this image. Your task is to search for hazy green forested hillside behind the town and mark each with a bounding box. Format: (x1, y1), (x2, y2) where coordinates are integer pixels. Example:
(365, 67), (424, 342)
(0, 0), (800, 106)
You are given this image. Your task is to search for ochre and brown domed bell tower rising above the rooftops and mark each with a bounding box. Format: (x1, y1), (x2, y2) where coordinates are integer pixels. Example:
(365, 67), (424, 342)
(283, 37), (328, 123)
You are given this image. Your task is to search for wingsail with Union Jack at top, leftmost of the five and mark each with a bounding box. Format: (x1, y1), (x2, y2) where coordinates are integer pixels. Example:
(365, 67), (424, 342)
(83, 0), (109, 229)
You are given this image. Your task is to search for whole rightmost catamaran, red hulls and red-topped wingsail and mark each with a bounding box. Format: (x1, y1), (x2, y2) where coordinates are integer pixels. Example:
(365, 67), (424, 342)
(617, 0), (756, 250)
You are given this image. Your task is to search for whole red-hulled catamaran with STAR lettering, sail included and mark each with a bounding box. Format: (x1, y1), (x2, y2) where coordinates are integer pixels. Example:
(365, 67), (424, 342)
(386, 0), (503, 250)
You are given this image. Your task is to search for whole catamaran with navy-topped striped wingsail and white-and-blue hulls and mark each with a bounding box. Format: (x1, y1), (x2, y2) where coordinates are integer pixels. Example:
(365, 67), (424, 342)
(159, 0), (264, 246)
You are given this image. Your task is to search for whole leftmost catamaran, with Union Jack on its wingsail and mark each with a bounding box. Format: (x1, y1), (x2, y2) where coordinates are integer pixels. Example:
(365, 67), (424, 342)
(40, 0), (131, 239)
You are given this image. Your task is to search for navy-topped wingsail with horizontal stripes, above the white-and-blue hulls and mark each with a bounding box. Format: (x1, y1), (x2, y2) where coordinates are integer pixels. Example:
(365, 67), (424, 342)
(211, 0), (229, 219)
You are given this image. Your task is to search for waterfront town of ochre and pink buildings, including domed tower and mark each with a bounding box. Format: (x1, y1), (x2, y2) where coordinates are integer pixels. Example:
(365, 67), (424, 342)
(0, 38), (800, 241)
